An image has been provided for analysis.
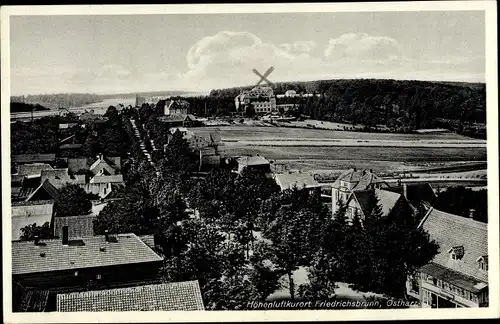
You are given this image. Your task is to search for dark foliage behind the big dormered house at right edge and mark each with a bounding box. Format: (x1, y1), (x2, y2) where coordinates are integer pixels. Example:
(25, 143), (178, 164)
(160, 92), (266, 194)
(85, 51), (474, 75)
(434, 186), (488, 223)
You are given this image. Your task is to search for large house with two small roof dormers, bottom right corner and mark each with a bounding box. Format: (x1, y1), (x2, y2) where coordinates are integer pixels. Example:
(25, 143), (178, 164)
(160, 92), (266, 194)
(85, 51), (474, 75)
(407, 205), (489, 308)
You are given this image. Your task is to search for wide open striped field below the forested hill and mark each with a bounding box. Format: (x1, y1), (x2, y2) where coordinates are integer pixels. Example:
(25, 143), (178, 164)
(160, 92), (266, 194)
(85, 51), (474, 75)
(193, 125), (486, 173)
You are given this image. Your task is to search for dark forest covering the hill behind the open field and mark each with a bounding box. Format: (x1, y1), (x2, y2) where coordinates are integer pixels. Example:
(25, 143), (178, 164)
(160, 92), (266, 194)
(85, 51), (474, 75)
(210, 79), (486, 136)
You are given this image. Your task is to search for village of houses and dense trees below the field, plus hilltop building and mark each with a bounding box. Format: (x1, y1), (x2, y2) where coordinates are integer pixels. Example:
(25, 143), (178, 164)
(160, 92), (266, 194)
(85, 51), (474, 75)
(11, 77), (488, 312)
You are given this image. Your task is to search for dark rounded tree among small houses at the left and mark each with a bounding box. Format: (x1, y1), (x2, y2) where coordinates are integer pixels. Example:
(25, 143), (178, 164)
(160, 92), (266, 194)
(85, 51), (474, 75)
(54, 184), (93, 217)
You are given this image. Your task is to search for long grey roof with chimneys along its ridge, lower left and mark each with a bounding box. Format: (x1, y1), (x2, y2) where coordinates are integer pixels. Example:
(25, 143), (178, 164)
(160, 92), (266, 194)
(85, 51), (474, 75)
(12, 234), (162, 275)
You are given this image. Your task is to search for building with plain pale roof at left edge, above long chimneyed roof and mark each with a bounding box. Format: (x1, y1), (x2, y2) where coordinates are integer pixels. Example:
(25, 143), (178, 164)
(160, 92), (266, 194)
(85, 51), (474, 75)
(11, 200), (54, 241)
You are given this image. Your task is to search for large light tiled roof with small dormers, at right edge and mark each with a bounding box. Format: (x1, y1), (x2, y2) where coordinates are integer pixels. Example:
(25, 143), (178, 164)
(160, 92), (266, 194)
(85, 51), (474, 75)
(420, 207), (488, 282)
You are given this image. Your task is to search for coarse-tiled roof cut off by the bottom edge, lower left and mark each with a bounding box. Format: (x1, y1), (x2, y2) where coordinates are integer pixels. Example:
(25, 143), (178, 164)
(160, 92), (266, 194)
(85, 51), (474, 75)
(57, 280), (204, 312)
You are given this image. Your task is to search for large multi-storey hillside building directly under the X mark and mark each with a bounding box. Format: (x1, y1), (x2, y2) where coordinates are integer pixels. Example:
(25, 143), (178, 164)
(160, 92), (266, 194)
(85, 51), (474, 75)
(234, 86), (276, 114)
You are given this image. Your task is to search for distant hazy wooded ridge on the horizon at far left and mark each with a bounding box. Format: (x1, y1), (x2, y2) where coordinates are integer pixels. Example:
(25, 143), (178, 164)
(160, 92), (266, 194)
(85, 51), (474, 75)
(10, 93), (102, 109)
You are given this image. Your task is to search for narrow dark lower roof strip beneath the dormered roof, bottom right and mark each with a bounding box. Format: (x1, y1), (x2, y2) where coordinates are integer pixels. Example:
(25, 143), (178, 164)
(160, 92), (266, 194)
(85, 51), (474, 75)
(420, 262), (487, 293)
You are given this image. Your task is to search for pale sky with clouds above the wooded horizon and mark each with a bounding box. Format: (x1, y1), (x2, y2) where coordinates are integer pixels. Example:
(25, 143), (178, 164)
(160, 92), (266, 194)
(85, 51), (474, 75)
(10, 11), (485, 95)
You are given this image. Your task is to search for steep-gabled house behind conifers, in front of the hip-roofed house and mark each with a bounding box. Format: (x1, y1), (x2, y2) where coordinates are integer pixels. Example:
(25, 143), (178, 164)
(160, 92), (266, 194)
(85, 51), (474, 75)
(346, 188), (415, 222)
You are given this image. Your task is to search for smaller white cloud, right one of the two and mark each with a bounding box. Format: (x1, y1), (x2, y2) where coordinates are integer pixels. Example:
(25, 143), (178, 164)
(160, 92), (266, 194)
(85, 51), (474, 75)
(325, 33), (401, 60)
